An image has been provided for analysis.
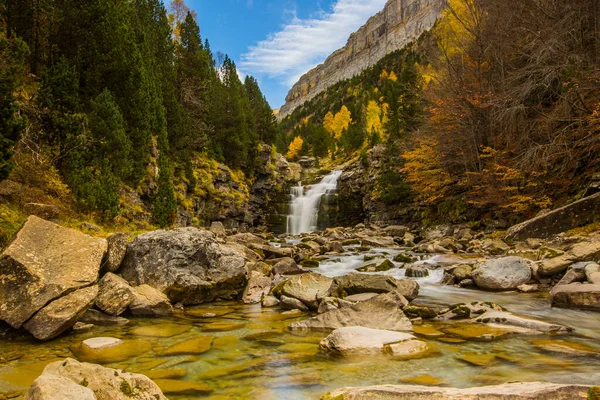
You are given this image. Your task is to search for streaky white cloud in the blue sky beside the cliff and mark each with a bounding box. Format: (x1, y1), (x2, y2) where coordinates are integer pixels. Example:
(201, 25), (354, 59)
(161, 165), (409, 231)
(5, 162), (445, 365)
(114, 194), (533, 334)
(240, 0), (386, 85)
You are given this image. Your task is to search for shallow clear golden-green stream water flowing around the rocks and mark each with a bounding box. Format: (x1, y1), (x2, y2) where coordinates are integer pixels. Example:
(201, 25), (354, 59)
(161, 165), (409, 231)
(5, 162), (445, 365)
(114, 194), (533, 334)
(0, 249), (600, 400)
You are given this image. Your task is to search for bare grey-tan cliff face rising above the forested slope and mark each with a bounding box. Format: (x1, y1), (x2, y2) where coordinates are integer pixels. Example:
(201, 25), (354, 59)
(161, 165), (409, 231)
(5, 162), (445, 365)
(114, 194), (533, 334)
(277, 0), (445, 119)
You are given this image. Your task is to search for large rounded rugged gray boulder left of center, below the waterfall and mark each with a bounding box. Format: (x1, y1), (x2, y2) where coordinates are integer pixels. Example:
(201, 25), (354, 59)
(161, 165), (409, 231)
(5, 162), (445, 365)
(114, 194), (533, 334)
(121, 228), (247, 305)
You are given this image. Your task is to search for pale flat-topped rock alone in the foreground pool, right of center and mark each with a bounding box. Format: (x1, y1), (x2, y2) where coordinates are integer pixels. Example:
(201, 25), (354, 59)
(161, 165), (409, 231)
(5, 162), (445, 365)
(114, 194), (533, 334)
(319, 326), (415, 355)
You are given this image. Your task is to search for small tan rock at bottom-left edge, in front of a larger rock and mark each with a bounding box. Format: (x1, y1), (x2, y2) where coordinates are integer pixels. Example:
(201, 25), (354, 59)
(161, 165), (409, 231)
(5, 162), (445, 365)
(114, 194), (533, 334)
(23, 375), (96, 400)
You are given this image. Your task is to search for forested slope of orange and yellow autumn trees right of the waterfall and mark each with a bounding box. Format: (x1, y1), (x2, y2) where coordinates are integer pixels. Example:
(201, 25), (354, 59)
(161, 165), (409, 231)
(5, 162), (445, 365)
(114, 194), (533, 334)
(279, 0), (600, 227)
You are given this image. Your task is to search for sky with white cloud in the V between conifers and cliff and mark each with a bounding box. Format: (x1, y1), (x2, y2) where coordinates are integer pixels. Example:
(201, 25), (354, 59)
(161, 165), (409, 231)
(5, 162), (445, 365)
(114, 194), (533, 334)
(186, 0), (386, 108)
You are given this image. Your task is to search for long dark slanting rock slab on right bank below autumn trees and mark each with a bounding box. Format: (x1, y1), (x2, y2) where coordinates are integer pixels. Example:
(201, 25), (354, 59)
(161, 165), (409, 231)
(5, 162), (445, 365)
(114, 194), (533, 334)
(506, 193), (600, 240)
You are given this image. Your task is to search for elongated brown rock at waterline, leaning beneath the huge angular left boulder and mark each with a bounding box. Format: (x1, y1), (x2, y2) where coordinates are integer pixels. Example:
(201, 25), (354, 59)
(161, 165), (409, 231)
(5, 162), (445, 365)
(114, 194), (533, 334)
(23, 286), (98, 340)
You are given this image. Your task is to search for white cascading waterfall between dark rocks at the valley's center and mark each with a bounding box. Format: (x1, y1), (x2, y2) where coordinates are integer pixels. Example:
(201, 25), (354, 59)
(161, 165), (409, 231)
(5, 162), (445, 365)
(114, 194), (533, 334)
(287, 170), (342, 235)
